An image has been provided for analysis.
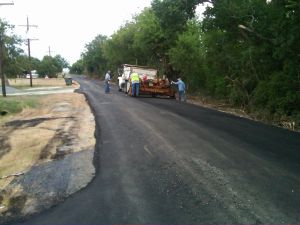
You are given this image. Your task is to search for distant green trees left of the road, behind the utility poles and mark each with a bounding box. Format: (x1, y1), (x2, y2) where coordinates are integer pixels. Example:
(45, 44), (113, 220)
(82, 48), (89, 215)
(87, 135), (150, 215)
(0, 18), (69, 78)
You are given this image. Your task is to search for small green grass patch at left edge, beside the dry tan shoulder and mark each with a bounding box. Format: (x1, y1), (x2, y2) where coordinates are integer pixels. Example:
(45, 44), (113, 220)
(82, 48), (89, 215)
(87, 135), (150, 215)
(0, 96), (38, 116)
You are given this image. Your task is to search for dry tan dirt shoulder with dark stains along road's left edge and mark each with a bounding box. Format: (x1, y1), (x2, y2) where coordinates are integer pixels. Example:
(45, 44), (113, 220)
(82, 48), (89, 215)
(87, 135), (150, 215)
(0, 93), (95, 224)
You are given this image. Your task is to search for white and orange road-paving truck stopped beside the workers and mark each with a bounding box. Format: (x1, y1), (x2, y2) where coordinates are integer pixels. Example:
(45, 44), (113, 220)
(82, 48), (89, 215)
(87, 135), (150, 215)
(118, 64), (175, 98)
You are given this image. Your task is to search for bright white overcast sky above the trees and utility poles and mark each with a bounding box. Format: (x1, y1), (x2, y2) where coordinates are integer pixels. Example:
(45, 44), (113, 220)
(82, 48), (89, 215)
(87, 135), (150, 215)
(0, 0), (206, 64)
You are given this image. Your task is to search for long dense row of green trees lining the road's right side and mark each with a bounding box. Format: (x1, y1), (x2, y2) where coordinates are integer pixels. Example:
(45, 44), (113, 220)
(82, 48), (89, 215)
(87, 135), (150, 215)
(71, 0), (300, 124)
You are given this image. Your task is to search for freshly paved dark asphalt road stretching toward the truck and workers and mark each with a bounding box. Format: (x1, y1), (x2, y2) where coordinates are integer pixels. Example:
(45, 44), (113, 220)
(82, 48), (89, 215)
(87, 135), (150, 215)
(17, 76), (300, 224)
